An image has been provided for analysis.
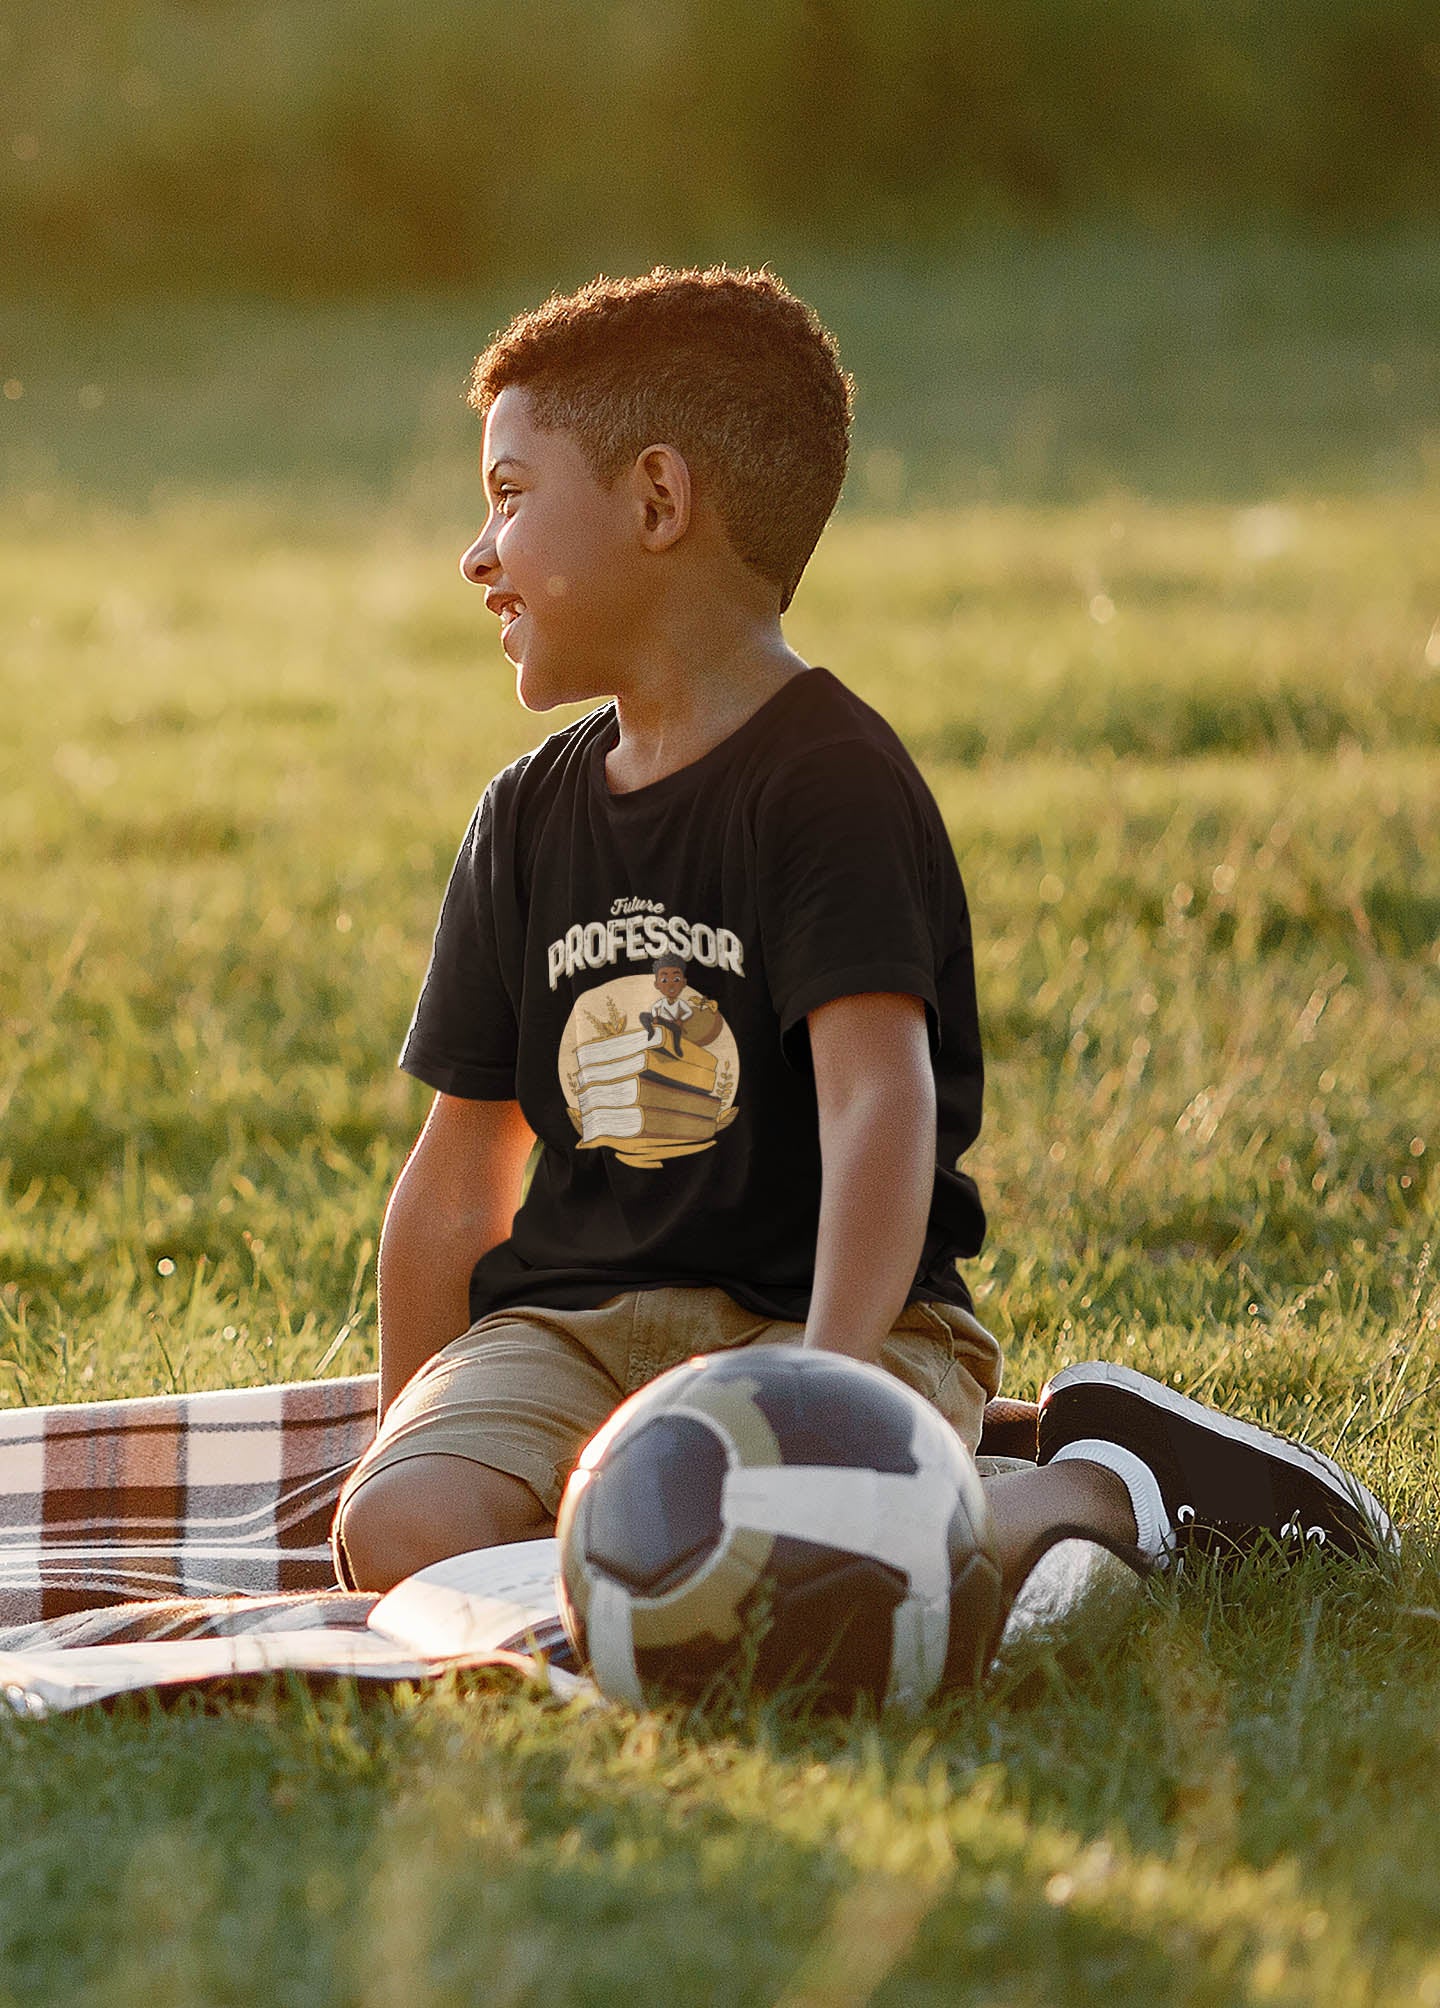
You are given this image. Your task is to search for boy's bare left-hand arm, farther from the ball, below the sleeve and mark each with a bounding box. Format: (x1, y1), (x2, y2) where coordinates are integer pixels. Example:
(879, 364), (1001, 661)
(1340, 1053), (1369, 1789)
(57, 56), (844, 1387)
(378, 1094), (534, 1416)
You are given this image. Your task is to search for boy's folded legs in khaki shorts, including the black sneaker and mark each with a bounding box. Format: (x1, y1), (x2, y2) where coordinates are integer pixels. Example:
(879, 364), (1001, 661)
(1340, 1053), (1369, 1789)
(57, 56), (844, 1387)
(335, 1289), (1394, 1592)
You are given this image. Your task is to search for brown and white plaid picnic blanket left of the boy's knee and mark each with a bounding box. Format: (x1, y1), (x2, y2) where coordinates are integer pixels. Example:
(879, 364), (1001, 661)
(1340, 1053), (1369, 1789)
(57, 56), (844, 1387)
(0, 1373), (376, 1645)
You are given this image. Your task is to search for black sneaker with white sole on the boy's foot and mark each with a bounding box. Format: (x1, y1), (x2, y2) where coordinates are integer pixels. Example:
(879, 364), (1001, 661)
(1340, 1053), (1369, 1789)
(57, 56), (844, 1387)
(1038, 1361), (1400, 1558)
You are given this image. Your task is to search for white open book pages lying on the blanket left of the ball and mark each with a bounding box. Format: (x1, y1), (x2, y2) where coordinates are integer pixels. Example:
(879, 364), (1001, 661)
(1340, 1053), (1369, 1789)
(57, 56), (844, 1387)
(0, 1540), (594, 1717)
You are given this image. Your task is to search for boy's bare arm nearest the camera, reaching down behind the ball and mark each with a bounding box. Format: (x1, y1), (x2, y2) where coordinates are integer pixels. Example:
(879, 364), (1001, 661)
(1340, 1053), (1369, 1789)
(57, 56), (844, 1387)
(805, 992), (936, 1361)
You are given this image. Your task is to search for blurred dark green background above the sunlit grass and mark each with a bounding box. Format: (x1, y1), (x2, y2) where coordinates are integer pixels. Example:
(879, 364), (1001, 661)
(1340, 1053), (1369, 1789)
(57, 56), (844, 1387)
(0, 0), (1440, 524)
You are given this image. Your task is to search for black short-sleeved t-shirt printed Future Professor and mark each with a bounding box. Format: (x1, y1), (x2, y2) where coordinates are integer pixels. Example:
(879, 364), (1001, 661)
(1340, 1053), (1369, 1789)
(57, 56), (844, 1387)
(402, 669), (984, 1319)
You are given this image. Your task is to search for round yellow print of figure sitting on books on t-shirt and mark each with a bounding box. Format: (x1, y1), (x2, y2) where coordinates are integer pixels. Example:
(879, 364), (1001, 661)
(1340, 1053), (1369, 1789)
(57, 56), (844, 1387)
(558, 971), (739, 1171)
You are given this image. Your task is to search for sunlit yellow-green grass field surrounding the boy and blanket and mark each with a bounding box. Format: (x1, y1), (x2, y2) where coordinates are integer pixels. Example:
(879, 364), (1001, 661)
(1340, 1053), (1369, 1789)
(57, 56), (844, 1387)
(0, 263), (1440, 2008)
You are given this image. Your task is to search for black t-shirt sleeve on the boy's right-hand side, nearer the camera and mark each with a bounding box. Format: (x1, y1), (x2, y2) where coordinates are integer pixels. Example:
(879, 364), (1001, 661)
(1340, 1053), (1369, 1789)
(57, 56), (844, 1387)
(755, 743), (938, 1066)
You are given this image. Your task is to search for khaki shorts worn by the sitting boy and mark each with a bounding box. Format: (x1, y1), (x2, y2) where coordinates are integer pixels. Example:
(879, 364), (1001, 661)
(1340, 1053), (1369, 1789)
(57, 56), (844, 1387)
(335, 1287), (1000, 1580)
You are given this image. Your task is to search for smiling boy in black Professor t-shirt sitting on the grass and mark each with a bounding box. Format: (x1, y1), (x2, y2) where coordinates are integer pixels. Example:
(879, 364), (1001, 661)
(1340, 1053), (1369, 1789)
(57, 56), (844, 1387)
(335, 269), (1394, 1590)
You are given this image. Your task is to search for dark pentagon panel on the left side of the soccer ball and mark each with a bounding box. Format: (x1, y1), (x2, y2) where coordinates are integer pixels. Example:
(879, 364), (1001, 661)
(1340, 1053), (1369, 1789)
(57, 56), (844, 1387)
(584, 1416), (727, 1596)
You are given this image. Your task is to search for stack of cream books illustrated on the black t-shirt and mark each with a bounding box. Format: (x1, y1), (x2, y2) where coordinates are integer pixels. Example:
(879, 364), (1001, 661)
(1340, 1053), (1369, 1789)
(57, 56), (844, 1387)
(574, 1032), (725, 1157)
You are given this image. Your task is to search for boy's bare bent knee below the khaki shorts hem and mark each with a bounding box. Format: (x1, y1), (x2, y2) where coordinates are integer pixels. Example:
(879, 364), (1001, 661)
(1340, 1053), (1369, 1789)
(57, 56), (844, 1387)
(335, 1454), (550, 1590)
